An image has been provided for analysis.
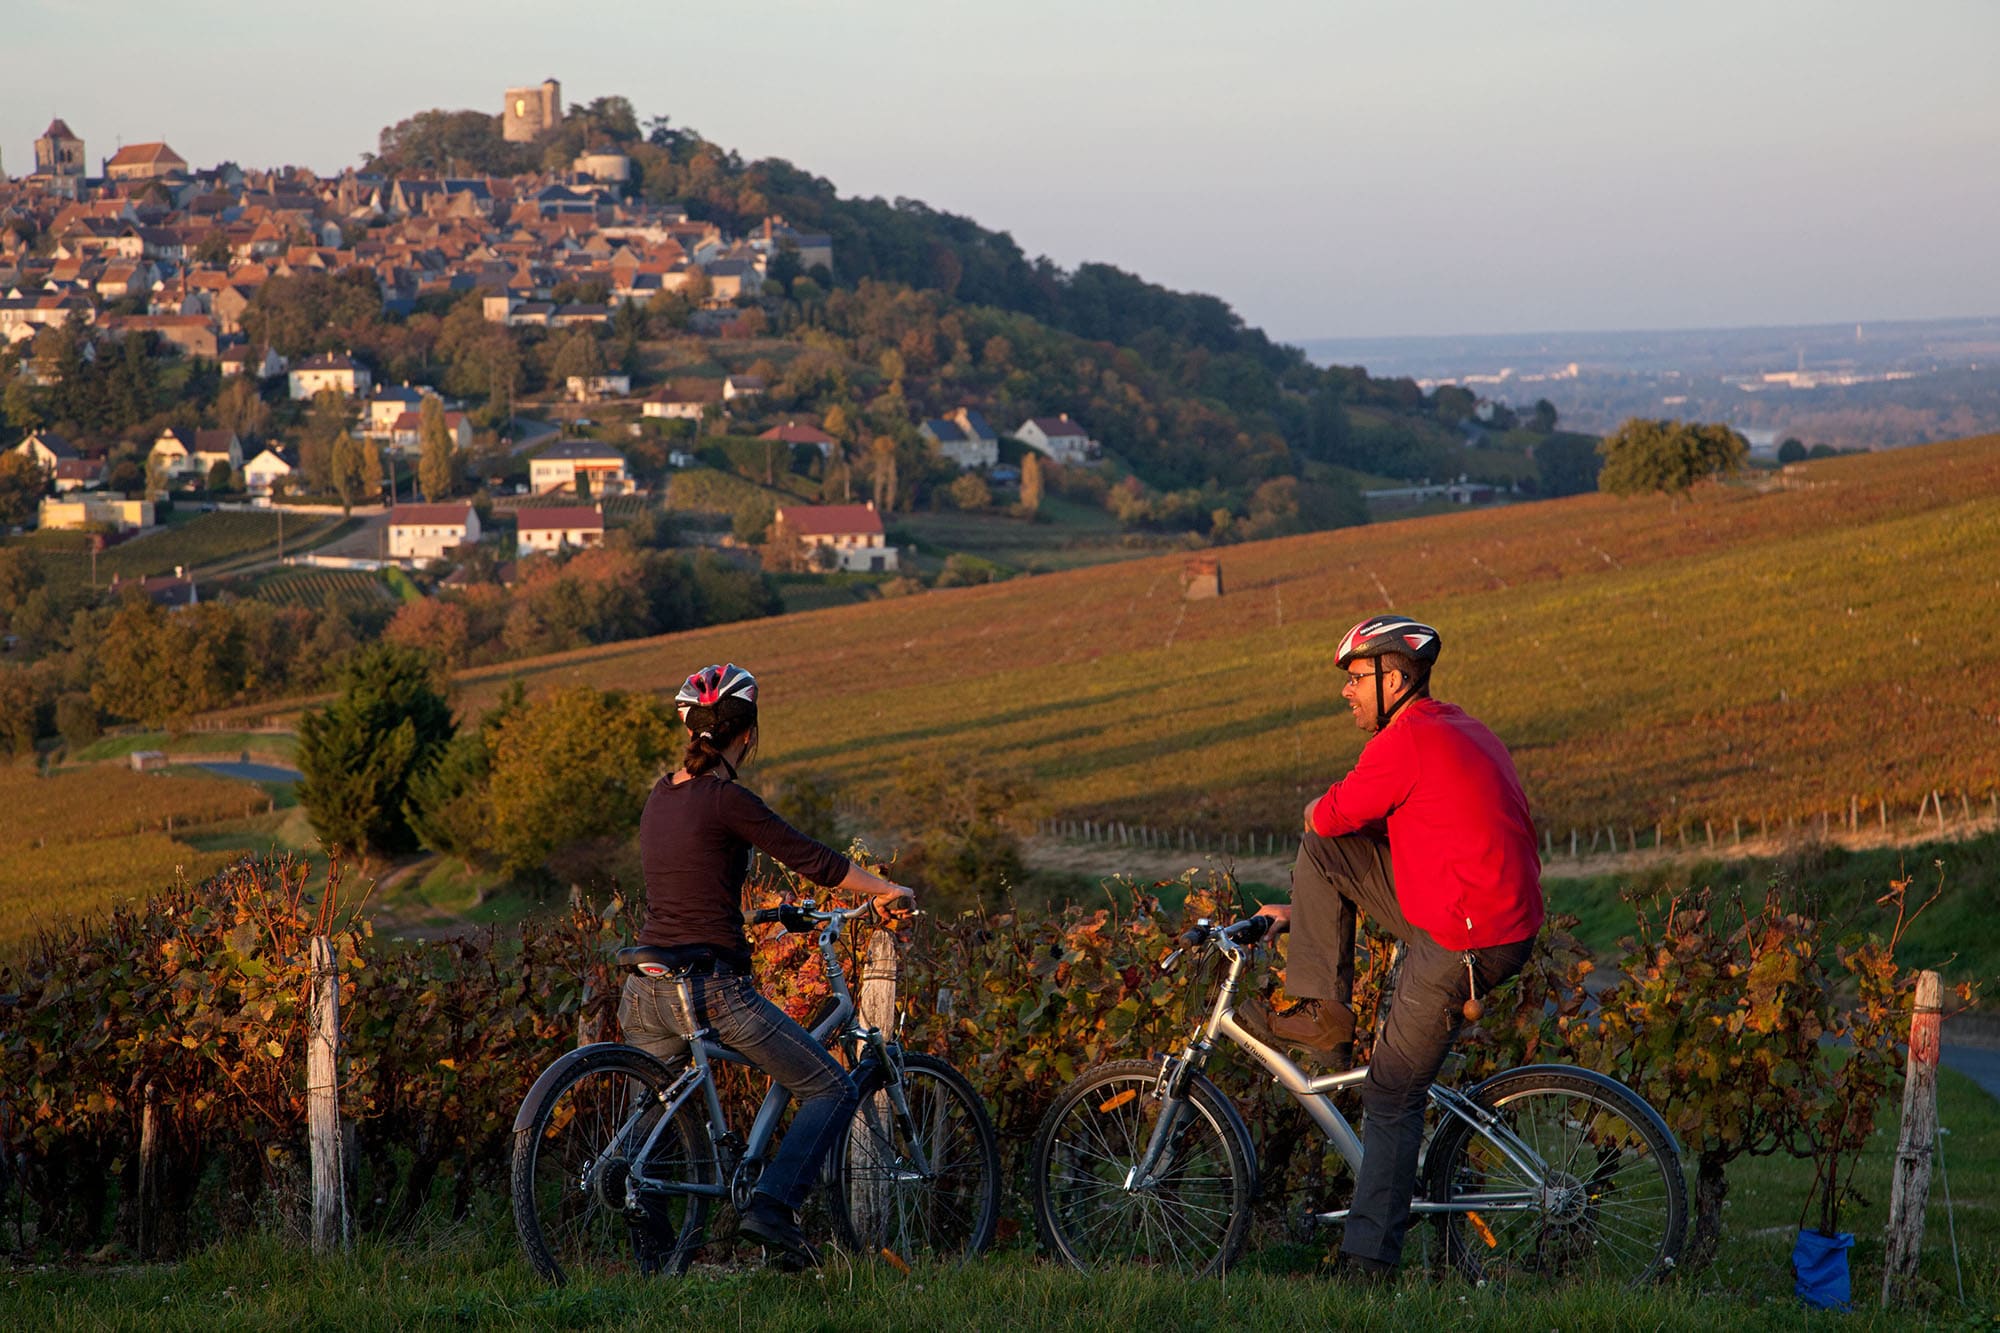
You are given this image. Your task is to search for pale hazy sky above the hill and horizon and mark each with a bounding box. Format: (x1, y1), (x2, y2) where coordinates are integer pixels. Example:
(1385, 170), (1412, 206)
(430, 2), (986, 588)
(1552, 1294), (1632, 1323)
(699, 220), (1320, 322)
(0, 0), (2000, 338)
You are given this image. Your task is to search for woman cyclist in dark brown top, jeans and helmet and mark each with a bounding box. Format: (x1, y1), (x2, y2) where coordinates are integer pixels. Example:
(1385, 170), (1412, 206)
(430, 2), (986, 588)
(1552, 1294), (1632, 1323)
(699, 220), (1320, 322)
(618, 664), (914, 1269)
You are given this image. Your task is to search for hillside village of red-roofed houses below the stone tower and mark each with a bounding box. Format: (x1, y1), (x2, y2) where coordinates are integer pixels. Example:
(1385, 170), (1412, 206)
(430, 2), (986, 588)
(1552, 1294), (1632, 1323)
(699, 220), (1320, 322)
(0, 91), (1144, 572)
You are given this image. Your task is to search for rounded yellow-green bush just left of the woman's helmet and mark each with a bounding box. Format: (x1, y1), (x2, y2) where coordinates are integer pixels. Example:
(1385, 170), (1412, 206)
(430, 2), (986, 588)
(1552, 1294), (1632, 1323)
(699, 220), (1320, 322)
(490, 685), (680, 873)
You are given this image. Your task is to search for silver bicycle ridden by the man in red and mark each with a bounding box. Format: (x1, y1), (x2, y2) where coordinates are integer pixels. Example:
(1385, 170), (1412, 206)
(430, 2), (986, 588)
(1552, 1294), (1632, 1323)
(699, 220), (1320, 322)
(1032, 917), (1688, 1283)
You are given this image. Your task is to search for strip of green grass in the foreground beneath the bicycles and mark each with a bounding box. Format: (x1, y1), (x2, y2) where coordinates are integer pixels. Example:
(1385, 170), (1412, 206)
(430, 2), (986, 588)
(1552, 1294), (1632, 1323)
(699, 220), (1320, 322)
(0, 1071), (2000, 1333)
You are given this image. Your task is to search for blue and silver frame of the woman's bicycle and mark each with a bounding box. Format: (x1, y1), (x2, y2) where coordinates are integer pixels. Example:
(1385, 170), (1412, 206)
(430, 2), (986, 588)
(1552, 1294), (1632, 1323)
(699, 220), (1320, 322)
(612, 903), (930, 1207)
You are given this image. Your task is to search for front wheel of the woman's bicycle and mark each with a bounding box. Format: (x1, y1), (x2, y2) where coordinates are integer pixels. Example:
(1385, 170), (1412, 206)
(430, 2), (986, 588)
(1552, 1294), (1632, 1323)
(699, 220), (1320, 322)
(828, 1053), (1000, 1263)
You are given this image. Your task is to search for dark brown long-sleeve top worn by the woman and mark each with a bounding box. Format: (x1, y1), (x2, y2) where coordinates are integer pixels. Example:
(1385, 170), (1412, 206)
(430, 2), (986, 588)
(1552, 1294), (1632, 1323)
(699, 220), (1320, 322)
(638, 773), (848, 969)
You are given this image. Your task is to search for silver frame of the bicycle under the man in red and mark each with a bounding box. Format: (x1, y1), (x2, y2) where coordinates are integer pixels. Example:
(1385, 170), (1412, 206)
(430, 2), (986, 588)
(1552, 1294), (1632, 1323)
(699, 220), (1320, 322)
(1124, 923), (1548, 1225)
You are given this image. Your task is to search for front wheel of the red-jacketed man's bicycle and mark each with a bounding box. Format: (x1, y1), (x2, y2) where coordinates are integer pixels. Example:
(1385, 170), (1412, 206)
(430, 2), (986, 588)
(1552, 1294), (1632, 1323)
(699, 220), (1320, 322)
(1030, 1061), (1256, 1277)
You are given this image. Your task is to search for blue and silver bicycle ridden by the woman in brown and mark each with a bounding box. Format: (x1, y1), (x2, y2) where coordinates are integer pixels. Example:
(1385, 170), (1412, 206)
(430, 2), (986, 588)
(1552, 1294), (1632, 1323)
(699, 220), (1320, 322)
(512, 903), (1000, 1283)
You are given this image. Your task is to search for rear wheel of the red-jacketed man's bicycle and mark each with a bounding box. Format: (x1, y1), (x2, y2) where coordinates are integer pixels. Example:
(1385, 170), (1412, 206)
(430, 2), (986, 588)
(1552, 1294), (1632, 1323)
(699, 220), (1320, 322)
(1424, 1065), (1688, 1287)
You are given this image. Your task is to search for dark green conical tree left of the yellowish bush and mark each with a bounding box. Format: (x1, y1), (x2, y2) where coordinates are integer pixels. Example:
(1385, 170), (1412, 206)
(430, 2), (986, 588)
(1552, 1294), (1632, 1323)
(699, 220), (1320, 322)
(298, 642), (456, 857)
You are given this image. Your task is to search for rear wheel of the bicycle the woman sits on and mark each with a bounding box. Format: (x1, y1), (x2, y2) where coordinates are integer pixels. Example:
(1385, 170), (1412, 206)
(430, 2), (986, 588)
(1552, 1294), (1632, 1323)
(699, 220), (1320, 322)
(510, 1045), (716, 1285)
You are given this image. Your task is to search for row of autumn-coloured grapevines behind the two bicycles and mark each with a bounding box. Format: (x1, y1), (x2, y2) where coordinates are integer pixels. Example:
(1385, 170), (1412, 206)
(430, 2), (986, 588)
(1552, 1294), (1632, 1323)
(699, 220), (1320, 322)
(0, 861), (1936, 1253)
